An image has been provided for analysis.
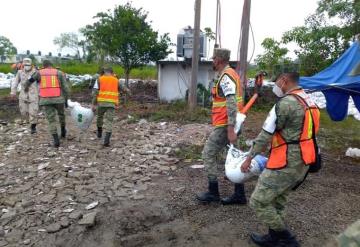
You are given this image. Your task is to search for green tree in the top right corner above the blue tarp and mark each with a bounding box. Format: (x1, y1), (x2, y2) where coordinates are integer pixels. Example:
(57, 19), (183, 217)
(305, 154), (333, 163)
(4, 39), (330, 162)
(282, 0), (360, 75)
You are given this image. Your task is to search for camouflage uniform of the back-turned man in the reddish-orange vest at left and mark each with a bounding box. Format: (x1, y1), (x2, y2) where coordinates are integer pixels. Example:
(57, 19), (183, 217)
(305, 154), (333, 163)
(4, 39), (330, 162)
(33, 70), (69, 135)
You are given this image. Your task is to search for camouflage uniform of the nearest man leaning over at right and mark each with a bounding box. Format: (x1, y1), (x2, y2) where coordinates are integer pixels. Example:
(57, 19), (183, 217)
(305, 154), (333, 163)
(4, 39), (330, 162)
(250, 87), (308, 231)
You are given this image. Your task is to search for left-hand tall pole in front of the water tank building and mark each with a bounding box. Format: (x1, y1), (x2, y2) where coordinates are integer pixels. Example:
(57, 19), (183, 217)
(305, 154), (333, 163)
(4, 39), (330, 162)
(188, 0), (201, 110)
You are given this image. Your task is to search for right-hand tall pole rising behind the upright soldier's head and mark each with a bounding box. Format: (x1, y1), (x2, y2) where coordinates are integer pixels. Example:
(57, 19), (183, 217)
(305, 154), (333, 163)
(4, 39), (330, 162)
(237, 0), (251, 100)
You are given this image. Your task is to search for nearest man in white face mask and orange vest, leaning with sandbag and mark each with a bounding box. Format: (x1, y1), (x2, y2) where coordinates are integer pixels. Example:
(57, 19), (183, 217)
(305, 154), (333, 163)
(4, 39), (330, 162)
(241, 72), (320, 247)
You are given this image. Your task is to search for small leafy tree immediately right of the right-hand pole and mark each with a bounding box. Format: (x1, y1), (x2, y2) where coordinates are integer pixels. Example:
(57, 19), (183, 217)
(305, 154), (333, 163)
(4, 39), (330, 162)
(255, 38), (291, 76)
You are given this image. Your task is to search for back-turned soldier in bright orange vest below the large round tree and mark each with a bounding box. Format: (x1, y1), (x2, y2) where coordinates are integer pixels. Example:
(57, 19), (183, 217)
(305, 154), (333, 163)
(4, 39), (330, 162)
(92, 67), (130, 147)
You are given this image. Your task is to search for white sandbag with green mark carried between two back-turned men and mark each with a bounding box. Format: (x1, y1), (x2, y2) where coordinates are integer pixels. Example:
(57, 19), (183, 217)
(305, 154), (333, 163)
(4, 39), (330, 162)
(68, 100), (94, 131)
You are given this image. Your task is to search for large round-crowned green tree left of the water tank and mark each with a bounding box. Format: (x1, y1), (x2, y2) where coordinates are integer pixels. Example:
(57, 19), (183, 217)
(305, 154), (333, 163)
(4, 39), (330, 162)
(83, 3), (171, 83)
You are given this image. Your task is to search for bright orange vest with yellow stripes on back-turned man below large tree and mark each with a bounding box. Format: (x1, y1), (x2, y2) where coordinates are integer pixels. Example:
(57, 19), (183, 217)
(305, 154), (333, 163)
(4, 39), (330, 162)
(97, 75), (119, 105)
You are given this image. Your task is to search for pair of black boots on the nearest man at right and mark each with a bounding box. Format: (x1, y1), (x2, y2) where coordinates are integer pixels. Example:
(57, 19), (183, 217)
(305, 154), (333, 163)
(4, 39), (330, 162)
(250, 229), (300, 247)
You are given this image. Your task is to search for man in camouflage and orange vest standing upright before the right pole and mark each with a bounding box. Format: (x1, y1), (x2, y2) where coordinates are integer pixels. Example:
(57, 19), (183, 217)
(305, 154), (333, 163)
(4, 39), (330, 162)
(196, 48), (246, 205)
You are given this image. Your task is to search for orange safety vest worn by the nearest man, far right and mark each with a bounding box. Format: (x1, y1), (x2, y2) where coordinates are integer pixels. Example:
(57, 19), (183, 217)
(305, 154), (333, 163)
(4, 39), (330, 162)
(266, 89), (320, 169)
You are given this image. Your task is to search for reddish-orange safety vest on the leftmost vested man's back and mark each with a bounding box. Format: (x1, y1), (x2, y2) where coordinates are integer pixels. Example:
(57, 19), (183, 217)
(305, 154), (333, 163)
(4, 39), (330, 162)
(39, 68), (61, 98)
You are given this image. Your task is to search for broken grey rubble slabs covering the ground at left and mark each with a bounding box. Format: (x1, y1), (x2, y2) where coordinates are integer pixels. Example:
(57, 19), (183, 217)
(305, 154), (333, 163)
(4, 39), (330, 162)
(0, 113), (210, 246)
